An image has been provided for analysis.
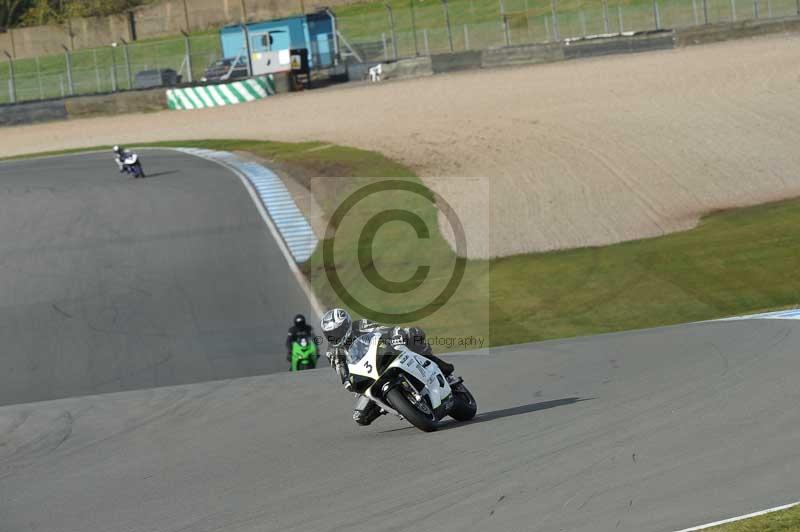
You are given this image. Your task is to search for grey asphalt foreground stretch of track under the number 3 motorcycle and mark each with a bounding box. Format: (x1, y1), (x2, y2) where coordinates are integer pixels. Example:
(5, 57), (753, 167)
(0, 314), (800, 532)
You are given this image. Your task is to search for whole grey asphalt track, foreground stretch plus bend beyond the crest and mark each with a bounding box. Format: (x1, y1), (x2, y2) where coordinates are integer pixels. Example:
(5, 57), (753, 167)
(0, 152), (800, 532)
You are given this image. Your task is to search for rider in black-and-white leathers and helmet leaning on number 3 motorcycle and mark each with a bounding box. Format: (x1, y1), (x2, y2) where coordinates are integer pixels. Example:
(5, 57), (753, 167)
(321, 308), (455, 426)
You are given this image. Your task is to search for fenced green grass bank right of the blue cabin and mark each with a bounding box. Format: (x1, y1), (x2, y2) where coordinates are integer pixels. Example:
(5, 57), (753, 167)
(336, 0), (800, 62)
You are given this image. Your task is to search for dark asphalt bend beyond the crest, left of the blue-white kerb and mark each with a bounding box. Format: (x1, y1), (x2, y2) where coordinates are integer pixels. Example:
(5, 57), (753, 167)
(0, 150), (318, 406)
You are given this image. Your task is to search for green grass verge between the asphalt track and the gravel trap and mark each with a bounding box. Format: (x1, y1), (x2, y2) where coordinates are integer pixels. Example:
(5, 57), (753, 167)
(3, 140), (800, 351)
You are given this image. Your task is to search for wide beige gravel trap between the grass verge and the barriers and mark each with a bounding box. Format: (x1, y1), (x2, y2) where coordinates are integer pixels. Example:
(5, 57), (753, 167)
(0, 35), (800, 257)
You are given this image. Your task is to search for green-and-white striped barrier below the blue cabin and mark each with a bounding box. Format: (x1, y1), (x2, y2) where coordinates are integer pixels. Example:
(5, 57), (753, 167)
(167, 76), (275, 109)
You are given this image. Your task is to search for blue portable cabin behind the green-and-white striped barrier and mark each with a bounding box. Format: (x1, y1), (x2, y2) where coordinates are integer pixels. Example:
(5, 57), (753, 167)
(219, 10), (337, 68)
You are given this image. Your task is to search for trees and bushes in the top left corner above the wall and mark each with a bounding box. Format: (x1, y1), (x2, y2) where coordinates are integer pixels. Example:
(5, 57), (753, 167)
(0, 0), (153, 30)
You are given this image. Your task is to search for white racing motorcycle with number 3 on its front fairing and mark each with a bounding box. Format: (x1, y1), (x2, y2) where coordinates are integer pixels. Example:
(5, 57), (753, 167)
(347, 332), (478, 432)
